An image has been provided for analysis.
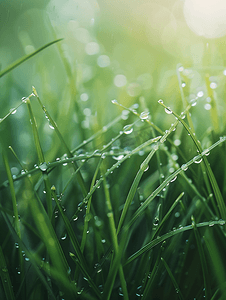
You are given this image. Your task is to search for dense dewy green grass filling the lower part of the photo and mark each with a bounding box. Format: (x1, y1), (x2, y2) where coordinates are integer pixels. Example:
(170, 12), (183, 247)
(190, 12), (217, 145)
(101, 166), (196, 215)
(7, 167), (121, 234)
(0, 35), (226, 300)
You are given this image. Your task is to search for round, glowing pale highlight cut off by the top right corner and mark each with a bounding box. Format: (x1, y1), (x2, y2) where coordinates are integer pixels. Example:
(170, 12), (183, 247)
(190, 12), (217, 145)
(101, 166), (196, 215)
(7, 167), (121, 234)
(184, 0), (226, 38)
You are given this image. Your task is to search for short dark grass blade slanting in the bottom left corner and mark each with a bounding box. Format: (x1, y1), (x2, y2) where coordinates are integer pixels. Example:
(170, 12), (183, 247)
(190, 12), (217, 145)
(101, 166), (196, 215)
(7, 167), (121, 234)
(0, 246), (15, 300)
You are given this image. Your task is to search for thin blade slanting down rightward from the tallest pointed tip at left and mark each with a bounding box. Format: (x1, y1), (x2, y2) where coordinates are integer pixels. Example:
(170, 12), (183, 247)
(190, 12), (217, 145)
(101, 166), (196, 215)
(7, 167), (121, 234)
(32, 86), (87, 197)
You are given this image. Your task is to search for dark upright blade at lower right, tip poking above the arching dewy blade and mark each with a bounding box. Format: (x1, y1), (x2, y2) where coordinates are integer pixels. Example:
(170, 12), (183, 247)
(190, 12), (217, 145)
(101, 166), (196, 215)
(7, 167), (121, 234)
(191, 216), (212, 299)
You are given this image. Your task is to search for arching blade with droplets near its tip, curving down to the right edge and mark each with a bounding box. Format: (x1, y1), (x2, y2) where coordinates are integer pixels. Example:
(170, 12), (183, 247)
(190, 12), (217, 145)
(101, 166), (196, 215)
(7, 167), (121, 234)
(159, 101), (226, 219)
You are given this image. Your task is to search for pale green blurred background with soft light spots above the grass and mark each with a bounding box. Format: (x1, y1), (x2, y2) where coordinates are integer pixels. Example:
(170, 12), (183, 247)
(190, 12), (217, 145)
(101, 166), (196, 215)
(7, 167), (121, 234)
(0, 0), (226, 172)
